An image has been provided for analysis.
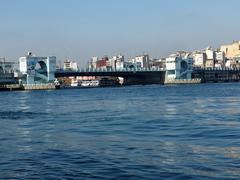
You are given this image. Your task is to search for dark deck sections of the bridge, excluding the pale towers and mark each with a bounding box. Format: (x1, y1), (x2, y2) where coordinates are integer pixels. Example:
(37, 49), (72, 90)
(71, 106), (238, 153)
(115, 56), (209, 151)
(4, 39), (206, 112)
(55, 67), (240, 84)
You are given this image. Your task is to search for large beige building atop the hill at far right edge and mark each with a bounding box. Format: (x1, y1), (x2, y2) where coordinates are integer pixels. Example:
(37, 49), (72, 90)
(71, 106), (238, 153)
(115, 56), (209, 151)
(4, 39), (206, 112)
(220, 41), (240, 59)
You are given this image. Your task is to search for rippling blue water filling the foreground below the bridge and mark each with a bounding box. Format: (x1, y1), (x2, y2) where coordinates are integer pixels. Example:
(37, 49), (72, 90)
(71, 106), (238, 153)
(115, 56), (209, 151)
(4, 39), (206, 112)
(0, 83), (240, 179)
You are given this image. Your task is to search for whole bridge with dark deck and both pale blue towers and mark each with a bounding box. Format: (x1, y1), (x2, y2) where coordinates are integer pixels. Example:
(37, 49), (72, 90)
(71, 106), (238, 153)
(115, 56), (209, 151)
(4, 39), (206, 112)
(15, 52), (240, 85)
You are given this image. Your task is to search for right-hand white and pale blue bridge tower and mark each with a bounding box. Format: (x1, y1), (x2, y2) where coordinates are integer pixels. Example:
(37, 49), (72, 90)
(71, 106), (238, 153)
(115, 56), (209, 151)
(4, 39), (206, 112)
(166, 54), (193, 79)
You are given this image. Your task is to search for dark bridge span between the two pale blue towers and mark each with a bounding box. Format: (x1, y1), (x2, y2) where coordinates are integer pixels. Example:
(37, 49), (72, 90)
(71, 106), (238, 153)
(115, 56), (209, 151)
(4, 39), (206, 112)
(55, 68), (165, 84)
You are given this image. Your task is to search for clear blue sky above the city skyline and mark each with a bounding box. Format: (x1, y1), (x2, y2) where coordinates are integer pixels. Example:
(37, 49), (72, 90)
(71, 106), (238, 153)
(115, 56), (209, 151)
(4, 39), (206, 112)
(0, 0), (240, 65)
